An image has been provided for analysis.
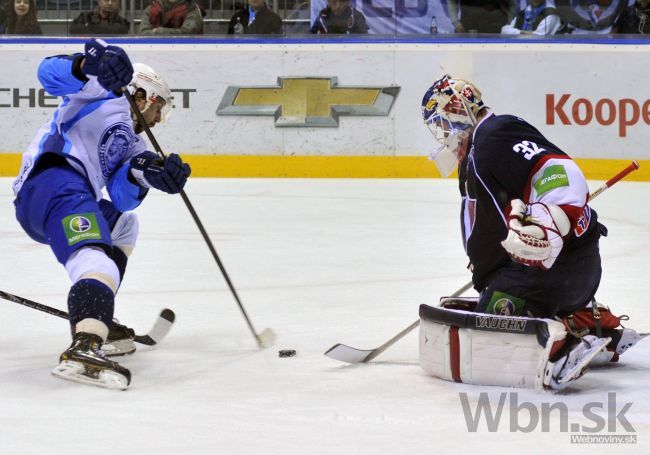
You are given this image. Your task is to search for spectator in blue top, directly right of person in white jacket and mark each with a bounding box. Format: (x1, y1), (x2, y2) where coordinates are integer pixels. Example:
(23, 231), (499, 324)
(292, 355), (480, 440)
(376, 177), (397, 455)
(555, 0), (634, 35)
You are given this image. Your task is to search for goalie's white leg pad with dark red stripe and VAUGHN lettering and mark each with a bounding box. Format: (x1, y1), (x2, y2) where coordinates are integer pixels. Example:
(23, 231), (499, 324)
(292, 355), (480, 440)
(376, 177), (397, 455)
(420, 305), (566, 389)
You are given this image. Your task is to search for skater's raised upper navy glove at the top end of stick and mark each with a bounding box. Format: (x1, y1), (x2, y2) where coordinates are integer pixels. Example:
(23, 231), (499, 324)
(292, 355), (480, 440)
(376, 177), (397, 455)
(83, 38), (133, 92)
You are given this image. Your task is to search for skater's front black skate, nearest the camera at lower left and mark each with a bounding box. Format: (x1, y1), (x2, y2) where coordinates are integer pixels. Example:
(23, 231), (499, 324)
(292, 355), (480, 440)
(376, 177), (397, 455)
(52, 332), (131, 390)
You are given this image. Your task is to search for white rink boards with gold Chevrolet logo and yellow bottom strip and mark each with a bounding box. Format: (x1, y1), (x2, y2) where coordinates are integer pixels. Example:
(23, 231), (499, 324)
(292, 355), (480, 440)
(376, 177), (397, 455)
(0, 38), (650, 180)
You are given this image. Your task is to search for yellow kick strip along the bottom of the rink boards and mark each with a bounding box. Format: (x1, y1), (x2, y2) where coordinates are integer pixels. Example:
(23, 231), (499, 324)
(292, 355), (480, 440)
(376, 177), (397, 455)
(0, 152), (650, 182)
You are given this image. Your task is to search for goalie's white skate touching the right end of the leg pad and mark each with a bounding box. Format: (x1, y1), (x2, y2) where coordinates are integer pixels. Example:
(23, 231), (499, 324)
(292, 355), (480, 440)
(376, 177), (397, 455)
(544, 335), (612, 390)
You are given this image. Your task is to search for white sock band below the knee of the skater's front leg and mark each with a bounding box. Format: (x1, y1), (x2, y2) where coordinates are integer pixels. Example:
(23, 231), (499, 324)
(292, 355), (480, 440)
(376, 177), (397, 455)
(65, 246), (120, 294)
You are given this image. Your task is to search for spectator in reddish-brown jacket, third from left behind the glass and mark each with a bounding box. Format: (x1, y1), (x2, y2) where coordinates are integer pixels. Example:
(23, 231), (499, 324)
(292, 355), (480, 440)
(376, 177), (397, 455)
(140, 0), (203, 35)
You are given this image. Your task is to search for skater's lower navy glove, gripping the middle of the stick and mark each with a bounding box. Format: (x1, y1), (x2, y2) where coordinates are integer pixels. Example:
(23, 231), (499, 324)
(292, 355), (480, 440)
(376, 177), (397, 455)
(130, 152), (192, 194)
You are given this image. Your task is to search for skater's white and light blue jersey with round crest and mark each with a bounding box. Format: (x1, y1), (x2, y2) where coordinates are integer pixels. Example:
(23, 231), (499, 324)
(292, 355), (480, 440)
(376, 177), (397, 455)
(13, 56), (146, 211)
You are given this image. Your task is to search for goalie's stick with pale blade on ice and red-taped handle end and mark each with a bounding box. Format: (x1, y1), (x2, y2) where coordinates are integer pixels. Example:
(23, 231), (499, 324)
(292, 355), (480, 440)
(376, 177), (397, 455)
(325, 161), (639, 363)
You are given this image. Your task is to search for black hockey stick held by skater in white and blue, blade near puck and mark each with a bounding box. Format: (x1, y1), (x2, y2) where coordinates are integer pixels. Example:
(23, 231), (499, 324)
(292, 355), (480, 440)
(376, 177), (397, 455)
(122, 88), (275, 348)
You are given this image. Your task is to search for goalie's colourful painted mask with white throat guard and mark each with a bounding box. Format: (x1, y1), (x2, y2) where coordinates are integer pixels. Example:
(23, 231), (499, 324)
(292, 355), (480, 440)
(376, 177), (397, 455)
(422, 74), (486, 177)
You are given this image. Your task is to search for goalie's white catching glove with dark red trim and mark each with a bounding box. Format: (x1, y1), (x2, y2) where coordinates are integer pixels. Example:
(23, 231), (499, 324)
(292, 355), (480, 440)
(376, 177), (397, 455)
(501, 199), (571, 269)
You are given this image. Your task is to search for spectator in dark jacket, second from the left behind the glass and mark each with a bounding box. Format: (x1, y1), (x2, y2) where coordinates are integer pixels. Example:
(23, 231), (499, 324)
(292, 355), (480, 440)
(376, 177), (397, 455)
(70, 0), (131, 36)
